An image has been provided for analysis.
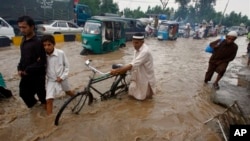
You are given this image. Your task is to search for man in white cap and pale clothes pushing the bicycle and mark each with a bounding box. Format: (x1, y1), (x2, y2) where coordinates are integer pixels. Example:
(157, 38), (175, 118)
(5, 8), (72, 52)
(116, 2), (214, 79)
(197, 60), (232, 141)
(110, 33), (155, 100)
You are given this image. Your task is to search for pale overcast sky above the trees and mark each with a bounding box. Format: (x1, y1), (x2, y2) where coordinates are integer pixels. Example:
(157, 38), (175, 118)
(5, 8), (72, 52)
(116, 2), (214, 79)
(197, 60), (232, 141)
(113, 0), (250, 19)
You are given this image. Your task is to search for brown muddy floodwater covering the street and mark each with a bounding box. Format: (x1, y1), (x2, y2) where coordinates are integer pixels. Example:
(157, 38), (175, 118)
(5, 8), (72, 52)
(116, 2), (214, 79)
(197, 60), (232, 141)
(0, 36), (248, 141)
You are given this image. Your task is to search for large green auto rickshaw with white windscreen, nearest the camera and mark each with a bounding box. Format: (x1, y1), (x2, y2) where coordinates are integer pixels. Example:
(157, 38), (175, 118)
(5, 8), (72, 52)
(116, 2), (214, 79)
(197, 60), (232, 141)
(81, 16), (126, 55)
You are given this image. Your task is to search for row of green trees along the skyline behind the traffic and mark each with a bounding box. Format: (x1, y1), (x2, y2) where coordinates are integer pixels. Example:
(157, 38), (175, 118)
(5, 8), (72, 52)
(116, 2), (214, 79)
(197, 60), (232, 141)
(80, 0), (250, 26)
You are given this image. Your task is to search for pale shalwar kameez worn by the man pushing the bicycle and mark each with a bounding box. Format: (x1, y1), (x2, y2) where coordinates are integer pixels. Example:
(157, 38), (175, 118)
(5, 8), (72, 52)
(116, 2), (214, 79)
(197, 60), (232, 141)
(129, 44), (155, 100)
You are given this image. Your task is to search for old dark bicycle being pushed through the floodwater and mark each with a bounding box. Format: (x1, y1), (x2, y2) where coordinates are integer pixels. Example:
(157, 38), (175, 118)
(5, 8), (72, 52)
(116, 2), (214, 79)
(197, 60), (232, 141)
(54, 60), (129, 125)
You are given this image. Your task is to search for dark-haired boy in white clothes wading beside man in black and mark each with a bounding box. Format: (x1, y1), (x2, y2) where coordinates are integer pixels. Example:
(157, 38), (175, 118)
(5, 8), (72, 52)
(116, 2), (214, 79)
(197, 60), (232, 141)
(42, 35), (74, 115)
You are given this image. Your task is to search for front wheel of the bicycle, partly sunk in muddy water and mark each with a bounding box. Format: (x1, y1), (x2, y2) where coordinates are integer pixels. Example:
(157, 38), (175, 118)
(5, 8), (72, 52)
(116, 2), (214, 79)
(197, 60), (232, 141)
(55, 91), (93, 125)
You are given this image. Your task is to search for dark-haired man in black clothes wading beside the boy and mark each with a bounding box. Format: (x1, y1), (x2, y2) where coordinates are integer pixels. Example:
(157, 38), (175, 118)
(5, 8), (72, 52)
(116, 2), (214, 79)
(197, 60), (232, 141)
(17, 16), (46, 108)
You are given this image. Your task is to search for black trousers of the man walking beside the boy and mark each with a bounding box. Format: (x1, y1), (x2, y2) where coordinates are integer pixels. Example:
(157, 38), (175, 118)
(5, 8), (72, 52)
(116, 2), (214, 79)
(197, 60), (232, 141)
(19, 75), (46, 108)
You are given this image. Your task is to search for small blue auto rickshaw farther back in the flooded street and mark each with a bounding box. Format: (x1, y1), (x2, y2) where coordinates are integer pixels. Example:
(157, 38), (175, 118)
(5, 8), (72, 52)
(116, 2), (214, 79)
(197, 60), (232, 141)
(157, 21), (179, 40)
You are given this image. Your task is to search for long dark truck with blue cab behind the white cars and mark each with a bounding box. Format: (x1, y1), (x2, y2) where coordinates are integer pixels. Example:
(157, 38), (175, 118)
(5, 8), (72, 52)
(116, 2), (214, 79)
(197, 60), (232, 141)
(0, 0), (91, 34)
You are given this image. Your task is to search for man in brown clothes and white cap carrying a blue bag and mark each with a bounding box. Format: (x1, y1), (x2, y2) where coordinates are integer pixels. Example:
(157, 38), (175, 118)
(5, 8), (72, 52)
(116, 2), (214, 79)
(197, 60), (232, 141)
(204, 31), (238, 90)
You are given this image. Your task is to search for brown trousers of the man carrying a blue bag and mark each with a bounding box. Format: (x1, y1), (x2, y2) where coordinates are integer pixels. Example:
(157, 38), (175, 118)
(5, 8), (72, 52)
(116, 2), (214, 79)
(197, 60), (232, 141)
(205, 62), (228, 81)
